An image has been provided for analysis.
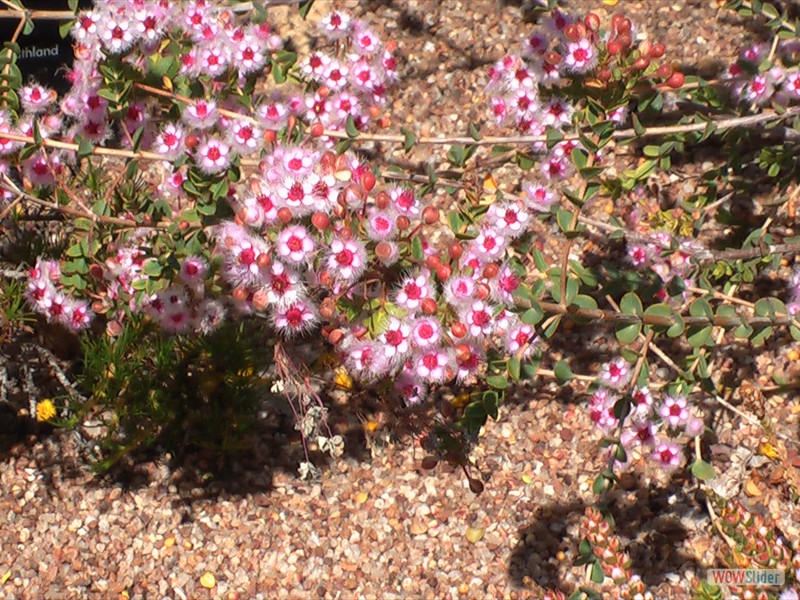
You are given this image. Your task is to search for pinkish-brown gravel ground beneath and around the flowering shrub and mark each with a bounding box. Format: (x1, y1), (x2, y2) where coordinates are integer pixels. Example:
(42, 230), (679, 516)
(0, 0), (800, 599)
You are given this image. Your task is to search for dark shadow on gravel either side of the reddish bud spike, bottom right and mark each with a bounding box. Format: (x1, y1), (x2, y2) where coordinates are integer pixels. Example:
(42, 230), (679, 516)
(508, 480), (702, 593)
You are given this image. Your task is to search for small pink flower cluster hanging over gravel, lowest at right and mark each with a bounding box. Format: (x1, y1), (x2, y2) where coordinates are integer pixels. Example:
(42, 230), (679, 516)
(589, 358), (703, 469)
